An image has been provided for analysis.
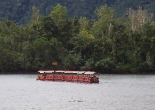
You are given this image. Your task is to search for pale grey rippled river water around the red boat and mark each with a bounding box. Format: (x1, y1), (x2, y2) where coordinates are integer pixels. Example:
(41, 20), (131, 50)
(0, 74), (155, 110)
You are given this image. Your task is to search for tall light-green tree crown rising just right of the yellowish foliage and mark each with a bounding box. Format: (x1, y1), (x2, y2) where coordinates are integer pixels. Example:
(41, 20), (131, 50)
(92, 5), (115, 38)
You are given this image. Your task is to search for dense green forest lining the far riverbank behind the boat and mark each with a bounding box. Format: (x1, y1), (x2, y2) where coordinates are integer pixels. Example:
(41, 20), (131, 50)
(0, 3), (155, 73)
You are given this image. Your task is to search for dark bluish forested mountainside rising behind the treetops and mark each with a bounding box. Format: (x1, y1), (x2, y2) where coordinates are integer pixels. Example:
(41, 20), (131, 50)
(0, 0), (155, 25)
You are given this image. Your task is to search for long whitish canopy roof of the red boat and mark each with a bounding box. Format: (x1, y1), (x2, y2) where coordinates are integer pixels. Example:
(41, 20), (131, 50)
(38, 70), (96, 74)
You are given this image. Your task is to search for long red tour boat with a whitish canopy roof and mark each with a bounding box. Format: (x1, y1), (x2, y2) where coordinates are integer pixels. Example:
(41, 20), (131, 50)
(37, 70), (99, 83)
